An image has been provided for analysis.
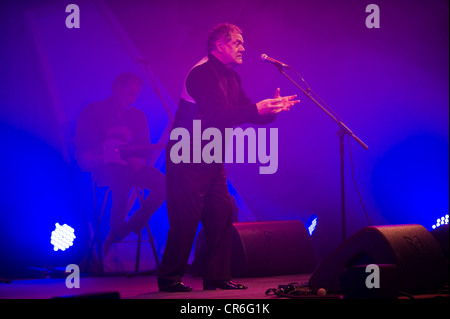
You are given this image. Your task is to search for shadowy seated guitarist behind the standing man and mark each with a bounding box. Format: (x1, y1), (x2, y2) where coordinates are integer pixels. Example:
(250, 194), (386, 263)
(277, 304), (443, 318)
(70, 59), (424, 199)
(74, 72), (166, 256)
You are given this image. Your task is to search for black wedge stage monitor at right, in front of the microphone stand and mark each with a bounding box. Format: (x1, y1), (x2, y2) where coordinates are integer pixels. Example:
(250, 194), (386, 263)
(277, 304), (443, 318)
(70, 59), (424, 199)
(309, 225), (448, 293)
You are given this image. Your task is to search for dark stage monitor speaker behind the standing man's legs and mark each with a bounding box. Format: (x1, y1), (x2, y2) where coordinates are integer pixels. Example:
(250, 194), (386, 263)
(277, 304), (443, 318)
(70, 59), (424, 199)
(193, 220), (316, 277)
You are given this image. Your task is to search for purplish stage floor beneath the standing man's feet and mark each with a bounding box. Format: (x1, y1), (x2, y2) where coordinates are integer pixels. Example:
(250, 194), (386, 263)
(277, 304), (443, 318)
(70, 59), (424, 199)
(0, 275), (316, 299)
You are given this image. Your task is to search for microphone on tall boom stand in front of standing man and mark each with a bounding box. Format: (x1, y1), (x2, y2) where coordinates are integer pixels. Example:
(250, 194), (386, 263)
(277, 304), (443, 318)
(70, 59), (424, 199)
(277, 65), (369, 242)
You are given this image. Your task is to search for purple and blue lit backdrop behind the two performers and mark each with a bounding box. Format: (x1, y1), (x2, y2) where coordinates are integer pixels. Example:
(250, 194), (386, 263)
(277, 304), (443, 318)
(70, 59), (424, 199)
(1, 0), (449, 264)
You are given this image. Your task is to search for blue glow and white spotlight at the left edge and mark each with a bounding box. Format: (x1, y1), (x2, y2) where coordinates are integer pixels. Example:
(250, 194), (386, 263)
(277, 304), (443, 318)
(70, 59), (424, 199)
(0, 123), (91, 278)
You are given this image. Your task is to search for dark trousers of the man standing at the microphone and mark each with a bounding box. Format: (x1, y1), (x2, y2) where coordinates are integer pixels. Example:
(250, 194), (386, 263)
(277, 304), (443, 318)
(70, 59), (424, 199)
(159, 158), (233, 281)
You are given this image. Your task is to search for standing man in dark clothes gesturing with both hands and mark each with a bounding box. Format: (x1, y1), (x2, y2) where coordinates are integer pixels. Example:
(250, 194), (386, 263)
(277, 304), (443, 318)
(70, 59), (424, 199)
(158, 23), (299, 292)
